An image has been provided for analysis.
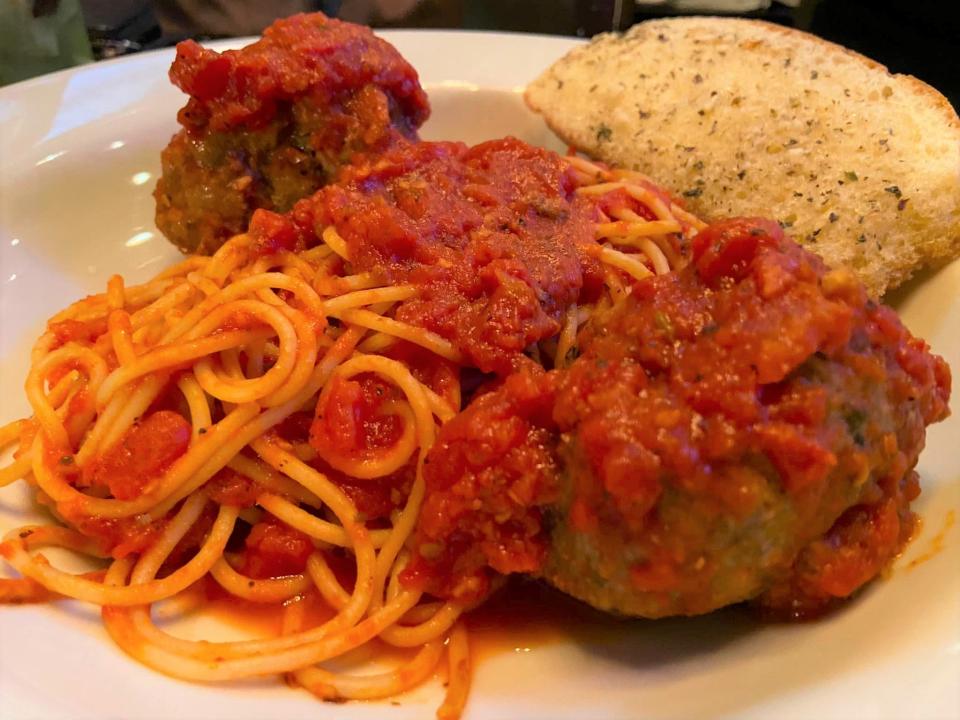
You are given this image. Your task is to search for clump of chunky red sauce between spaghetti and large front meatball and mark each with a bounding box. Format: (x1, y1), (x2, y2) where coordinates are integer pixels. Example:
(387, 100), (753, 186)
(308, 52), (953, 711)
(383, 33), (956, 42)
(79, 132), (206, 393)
(402, 371), (558, 601)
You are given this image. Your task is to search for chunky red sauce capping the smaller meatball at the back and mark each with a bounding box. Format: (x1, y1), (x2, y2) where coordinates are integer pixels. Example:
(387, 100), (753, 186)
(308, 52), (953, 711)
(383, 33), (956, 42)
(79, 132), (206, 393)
(170, 13), (429, 132)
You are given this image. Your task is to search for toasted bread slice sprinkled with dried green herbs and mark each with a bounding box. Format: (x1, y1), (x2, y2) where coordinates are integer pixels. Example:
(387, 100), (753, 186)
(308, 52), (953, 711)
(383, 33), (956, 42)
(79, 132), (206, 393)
(526, 17), (960, 297)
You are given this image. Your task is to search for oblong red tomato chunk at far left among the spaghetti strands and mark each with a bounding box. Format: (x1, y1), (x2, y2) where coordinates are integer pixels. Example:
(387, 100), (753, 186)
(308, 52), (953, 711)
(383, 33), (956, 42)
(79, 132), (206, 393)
(83, 410), (190, 500)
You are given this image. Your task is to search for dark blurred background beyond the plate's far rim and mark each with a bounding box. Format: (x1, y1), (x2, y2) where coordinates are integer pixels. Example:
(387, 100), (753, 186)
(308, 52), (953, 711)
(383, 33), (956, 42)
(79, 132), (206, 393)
(0, 0), (960, 106)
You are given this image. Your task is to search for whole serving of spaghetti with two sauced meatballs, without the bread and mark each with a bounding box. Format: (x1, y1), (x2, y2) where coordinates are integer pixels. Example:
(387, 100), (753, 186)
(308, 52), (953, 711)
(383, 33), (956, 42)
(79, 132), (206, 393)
(0, 11), (950, 718)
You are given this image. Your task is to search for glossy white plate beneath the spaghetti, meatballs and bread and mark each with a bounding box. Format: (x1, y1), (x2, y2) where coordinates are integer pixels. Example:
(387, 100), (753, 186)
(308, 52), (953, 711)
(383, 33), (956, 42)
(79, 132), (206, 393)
(0, 32), (960, 720)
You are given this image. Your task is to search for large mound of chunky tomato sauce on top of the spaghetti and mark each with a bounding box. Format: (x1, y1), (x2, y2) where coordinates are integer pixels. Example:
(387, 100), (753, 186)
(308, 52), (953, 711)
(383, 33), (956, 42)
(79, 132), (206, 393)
(254, 138), (601, 373)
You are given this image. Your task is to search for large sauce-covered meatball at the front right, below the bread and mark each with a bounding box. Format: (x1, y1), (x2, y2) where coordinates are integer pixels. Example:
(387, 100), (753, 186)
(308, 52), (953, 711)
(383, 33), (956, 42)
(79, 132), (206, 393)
(402, 219), (950, 618)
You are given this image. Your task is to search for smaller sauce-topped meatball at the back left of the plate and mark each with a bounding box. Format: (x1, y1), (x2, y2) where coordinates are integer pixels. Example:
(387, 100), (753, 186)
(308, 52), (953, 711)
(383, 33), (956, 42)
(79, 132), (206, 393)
(154, 13), (429, 254)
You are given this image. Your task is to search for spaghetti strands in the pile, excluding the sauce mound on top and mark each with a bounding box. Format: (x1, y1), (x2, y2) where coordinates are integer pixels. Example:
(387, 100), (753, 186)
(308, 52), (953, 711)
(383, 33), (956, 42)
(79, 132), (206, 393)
(0, 149), (703, 718)
